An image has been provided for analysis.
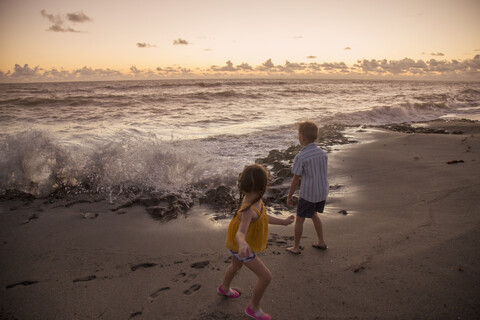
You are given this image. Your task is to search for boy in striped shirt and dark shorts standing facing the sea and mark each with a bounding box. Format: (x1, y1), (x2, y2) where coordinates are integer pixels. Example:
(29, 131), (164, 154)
(287, 121), (329, 254)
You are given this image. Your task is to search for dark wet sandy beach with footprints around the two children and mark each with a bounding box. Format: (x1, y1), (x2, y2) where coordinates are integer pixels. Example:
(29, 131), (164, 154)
(0, 121), (480, 320)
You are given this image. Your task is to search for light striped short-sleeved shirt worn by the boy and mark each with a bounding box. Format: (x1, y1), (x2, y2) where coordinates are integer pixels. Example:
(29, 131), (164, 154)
(292, 142), (329, 203)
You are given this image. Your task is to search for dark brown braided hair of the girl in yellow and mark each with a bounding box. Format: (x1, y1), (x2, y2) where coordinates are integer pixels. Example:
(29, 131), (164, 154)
(235, 164), (268, 215)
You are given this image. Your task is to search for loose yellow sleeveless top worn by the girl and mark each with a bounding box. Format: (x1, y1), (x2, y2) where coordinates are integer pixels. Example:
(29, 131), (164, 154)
(225, 200), (268, 252)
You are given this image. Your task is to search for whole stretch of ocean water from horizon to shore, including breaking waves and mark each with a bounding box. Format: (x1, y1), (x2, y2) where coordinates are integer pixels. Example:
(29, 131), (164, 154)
(0, 80), (480, 197)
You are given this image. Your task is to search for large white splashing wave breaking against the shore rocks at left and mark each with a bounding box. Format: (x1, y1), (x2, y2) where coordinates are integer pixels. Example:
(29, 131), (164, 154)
(0, 131), (234, 197)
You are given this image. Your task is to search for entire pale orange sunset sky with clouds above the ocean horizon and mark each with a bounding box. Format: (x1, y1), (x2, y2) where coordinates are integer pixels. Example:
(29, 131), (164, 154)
(0, 0), (480, 82)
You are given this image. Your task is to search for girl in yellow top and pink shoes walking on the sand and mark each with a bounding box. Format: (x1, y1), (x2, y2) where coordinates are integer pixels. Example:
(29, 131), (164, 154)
(217, 164), (295, 320)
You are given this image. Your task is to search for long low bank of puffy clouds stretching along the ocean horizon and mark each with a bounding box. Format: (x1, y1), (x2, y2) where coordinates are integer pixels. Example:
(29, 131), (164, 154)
(0, 54), (480, 82)
